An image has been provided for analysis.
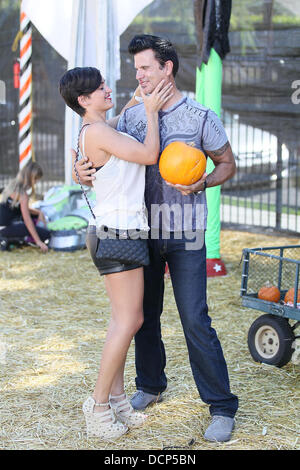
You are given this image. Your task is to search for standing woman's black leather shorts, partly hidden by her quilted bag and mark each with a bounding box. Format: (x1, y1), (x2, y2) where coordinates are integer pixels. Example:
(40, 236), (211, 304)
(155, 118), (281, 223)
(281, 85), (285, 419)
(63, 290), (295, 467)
(86, 225), (143, 276)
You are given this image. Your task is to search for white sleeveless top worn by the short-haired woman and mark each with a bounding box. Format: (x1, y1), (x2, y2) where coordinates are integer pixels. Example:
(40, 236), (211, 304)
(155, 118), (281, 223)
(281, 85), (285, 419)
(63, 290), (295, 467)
(82, 127), (149, 230)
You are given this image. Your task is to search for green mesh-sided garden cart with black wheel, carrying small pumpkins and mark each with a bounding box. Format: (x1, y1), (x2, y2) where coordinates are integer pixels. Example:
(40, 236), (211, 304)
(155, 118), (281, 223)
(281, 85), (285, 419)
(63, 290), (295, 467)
(241, 245), (300, 367)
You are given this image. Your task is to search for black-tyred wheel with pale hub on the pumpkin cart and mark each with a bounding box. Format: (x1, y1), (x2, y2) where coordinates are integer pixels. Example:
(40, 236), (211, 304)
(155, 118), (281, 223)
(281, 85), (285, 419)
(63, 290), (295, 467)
(248, 314), (295, 367)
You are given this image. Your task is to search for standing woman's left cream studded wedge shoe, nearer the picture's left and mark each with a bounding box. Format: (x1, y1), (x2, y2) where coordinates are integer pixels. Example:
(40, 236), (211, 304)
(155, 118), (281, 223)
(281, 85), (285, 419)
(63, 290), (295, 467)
(82, 397), (128, 441)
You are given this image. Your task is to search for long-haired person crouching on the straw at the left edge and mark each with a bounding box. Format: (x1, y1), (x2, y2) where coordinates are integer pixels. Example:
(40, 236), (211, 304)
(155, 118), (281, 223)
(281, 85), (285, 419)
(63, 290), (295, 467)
(0, 162), (50, 253)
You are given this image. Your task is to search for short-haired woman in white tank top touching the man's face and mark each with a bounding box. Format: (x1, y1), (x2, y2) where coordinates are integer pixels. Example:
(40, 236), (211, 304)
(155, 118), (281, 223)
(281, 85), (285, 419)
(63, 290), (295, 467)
(60, 67), (171, 440)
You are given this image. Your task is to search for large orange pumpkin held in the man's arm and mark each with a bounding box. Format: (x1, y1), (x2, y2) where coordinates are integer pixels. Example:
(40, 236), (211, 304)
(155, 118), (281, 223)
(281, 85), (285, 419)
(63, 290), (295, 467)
(159, 142), (206, 186)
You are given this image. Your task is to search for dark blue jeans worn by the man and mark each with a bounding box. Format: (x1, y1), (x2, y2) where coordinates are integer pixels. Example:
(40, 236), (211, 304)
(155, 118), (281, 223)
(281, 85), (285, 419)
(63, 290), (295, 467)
(135, 229), (238, 417)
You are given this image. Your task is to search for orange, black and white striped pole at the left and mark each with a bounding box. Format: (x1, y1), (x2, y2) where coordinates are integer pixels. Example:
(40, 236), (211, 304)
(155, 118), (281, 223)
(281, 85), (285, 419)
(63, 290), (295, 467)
(19, 11), (32, 168)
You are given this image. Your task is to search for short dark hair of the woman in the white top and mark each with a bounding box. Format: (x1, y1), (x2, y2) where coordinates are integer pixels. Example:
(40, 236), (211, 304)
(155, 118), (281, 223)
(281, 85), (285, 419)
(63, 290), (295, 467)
(59, 67), (103, 116)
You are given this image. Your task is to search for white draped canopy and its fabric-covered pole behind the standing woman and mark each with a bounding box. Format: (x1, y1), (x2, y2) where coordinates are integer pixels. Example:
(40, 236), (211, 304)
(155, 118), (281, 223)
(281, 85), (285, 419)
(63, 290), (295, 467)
(22, 0), (152, 184)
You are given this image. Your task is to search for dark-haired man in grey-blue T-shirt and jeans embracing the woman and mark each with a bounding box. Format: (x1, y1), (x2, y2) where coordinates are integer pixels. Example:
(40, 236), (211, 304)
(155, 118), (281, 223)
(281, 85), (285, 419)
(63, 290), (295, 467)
(77, 35), (238, 442)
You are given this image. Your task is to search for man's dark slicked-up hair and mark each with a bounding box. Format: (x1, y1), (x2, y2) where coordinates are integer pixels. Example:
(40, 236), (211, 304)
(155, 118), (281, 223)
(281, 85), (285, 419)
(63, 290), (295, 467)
(128, 34), (179, 77)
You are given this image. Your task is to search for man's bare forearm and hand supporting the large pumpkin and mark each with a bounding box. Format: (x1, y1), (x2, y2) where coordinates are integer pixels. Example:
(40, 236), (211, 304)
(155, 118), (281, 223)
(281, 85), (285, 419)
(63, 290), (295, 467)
(168, 141), (236, 196)
